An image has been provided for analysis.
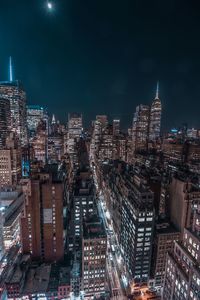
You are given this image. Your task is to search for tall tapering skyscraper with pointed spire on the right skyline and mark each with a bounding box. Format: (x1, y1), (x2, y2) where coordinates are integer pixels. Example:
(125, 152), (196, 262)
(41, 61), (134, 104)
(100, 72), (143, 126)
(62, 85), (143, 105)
(149, 83), (162, 142)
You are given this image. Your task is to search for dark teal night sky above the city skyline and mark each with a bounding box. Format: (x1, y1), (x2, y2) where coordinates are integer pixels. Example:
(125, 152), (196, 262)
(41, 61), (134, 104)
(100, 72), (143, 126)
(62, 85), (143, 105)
(0, 0), (200, 128)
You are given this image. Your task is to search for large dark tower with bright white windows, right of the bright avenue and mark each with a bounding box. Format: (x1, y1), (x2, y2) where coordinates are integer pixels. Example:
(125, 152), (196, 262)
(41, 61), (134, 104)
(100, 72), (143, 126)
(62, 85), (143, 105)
(120, 175), (154, 282)
